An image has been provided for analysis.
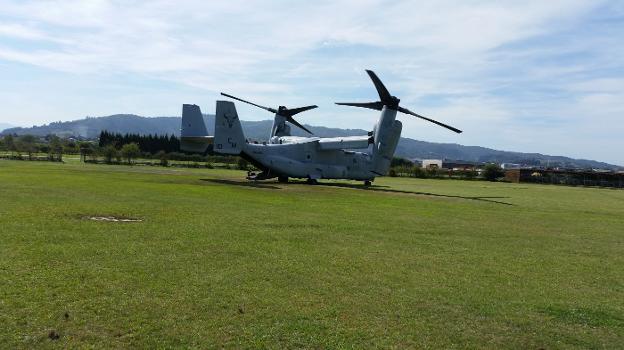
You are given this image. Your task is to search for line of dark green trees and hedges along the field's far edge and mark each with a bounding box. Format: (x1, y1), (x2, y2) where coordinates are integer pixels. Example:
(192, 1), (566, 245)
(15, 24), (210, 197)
(0, 131), (504, 181)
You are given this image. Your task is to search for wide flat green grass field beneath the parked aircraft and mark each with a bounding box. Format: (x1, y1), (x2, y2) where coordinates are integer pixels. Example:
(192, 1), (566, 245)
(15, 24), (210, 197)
(0, 161), (624, 349)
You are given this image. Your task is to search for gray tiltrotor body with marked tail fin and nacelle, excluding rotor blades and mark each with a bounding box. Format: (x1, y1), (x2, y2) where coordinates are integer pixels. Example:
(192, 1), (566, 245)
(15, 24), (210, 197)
(214, 101), (401, 180)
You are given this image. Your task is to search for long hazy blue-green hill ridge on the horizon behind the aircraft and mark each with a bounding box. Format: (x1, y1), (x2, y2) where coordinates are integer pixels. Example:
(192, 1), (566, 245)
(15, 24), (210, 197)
(4, 114), (622, 170)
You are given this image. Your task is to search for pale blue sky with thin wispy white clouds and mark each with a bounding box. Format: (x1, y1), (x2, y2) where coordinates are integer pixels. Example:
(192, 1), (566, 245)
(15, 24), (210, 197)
(0, 0), (624, 165)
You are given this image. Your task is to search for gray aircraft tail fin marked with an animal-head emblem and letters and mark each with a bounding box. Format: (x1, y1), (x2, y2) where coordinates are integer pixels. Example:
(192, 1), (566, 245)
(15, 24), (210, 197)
(214, 101), (245, 154)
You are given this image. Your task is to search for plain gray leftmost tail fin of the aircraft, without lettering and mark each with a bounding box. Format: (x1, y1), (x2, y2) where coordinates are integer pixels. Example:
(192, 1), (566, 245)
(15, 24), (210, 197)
(180, 104), (214, 154)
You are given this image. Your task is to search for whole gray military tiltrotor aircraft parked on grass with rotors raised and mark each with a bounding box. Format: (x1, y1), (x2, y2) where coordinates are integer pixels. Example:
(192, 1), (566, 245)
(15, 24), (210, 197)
(181, 70), (461, 185)
